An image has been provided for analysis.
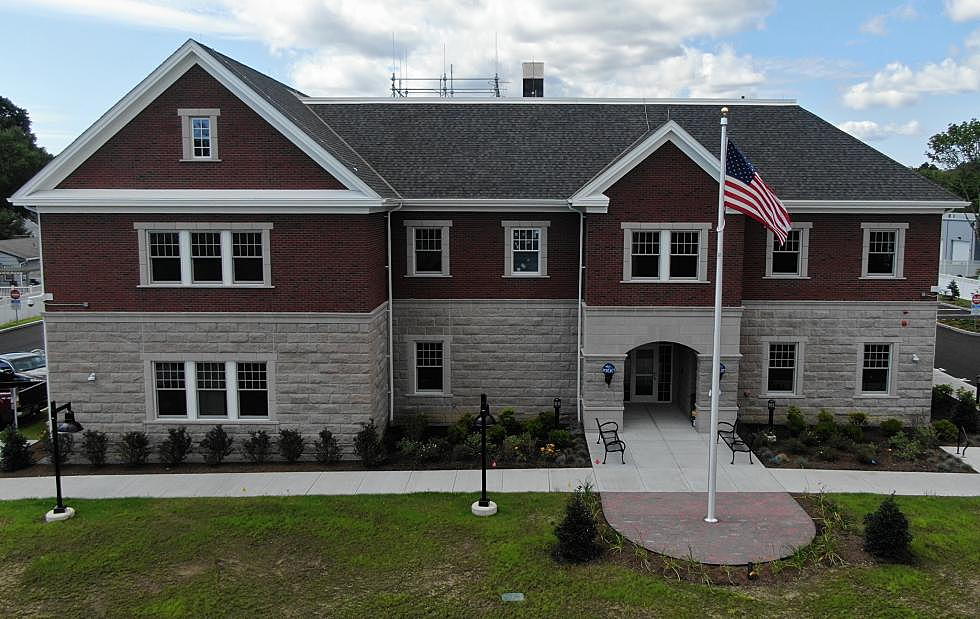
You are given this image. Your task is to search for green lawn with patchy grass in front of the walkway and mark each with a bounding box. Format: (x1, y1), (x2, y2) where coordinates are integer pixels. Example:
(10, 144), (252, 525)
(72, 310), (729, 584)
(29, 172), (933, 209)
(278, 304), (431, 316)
(0, 494), (980, 617)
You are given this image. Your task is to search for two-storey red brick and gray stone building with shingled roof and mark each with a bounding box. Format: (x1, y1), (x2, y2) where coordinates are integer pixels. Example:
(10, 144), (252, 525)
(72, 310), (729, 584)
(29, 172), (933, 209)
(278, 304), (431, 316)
(12, 41), (959, 452)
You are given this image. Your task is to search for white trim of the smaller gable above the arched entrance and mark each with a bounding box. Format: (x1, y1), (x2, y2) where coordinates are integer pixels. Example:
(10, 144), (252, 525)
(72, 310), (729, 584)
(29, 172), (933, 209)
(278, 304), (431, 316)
(569, 120), (721, 208)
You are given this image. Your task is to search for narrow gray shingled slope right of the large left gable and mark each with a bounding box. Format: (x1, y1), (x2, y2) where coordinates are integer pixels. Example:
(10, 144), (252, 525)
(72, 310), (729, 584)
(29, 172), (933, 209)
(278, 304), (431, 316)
(198, 43), (398, 198)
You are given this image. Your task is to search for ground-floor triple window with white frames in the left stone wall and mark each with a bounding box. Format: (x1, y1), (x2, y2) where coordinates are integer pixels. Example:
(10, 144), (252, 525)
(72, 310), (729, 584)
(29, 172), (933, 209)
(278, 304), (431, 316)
(147, 355), (271, 421)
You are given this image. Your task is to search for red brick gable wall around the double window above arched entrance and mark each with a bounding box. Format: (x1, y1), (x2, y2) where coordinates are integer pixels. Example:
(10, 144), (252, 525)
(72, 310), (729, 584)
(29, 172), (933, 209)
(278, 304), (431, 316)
(585, 142), (743, 306)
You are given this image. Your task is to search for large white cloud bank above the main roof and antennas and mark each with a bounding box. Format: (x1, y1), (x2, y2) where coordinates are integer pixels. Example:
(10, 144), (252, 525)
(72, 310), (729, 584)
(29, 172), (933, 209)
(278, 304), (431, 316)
(15, 0), (775, 97)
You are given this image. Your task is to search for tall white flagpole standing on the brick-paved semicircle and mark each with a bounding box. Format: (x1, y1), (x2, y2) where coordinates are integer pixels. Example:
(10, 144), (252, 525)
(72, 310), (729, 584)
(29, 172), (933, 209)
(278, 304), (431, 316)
(704, 107), (728, 523)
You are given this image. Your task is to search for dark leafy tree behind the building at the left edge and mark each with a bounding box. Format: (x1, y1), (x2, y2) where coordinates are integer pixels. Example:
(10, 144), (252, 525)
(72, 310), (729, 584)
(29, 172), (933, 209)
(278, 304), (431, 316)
(0, 97), (52, 232)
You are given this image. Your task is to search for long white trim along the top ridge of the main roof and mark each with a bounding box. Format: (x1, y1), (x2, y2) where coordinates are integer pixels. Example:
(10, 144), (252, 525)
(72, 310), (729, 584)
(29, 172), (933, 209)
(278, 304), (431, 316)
(299, 97), (797, 106)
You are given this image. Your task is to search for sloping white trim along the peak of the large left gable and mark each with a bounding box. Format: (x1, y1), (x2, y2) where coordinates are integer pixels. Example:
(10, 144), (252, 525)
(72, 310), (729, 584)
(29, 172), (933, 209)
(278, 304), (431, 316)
(12, 40), (380, 205)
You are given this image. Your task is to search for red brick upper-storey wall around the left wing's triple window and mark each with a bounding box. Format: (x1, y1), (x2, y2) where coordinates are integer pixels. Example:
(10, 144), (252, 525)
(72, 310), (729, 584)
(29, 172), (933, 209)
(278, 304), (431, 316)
(41, 215), (388, 312)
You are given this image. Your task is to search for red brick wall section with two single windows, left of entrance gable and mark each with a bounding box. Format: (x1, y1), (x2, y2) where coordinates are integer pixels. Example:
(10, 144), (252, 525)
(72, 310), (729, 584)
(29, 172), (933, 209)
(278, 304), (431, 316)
(391, 212), (579, 299)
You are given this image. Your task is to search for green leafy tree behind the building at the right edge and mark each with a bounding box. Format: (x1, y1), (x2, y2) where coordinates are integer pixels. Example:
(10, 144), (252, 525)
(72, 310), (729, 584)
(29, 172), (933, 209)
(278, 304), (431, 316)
(919, 118), (980, 239)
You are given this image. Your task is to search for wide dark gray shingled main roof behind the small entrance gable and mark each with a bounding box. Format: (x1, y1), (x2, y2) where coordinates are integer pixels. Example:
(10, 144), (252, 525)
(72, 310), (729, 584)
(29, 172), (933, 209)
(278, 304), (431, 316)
(311, 102), (957, 200)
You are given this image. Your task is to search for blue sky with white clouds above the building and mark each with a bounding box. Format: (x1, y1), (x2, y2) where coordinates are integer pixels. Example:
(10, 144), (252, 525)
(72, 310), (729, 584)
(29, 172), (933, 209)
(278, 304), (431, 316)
(0, 0), (980, 165)
